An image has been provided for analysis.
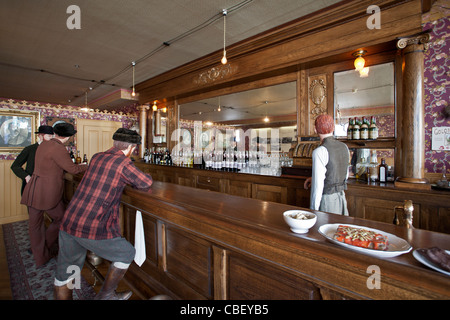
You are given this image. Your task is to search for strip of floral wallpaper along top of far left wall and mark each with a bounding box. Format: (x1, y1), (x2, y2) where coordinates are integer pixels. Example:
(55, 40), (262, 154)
(0, 98), (138, 160)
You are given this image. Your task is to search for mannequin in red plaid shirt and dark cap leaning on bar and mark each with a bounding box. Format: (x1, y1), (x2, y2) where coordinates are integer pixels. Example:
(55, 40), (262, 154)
(54, 128), (152, 300)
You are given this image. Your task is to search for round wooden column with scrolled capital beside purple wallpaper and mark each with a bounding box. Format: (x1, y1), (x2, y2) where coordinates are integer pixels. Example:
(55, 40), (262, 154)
(396, 33), (430, 189)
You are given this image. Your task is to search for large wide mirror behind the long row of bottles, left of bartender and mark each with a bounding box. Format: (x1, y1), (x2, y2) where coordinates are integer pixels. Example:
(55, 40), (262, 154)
(177, 81), (297, 175)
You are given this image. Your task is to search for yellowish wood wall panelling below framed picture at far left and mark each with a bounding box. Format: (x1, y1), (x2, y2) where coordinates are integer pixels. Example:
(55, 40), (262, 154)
(0, 160), (28, 224)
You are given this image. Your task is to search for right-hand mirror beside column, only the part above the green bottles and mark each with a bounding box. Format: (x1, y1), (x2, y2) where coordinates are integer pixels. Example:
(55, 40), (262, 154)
(334, 62), (395, 138)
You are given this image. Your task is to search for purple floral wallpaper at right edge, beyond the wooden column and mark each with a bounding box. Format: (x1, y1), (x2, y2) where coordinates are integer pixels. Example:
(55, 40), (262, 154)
(422, 1), (450, 174)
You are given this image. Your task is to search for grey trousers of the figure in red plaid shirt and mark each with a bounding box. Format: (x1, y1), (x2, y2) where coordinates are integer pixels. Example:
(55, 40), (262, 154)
(55, 231), (136, 283)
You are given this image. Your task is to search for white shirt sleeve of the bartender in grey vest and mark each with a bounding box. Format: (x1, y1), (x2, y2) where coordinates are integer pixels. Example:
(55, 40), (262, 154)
(309, 146), (329, 210)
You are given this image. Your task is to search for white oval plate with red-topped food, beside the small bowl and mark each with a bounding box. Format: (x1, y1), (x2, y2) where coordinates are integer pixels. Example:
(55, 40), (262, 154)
(319, 223), (412, 258)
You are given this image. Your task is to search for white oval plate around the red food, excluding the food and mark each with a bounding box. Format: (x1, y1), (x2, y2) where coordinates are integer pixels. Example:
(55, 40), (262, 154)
(319, 223), (412, 258)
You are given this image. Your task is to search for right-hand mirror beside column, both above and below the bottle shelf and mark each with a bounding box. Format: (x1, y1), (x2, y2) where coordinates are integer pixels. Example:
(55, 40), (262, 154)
(334, 62), (395, 182)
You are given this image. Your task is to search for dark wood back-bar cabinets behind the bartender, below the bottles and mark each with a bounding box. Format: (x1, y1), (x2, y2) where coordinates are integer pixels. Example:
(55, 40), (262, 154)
(136, 162), (450, 234)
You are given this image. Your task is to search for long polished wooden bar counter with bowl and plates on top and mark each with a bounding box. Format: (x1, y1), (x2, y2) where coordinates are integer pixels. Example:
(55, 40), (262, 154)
(65, 175), (450, 300)
